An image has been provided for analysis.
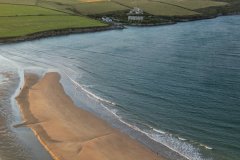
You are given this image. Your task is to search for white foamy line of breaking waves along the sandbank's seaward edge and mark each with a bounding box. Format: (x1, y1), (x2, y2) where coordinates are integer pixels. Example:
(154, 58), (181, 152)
(64, 72), (206, 160)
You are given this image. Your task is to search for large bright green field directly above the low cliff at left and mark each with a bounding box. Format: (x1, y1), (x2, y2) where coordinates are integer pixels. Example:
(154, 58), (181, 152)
(0, 16), (106, 37)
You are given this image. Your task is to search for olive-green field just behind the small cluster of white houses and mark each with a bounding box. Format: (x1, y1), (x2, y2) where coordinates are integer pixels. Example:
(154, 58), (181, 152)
(75, 1), (129, 15)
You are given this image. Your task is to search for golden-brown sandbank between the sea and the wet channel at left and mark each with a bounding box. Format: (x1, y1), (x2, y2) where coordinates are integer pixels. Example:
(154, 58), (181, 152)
(16, 72), (164, 160)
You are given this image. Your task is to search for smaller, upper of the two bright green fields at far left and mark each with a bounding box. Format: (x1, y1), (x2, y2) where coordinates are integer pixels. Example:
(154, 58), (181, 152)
(0, 4), (66, 16)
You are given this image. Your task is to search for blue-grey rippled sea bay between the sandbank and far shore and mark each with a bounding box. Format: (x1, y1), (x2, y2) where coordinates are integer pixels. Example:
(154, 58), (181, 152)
(0, 16), (240, 160)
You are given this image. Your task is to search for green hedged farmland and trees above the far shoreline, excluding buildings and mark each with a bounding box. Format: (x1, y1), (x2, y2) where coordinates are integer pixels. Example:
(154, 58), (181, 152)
(0, 0), (240, 39)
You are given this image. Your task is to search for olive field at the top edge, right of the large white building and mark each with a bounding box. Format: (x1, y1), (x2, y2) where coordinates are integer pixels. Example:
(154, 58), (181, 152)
(153, 0), (227, 10)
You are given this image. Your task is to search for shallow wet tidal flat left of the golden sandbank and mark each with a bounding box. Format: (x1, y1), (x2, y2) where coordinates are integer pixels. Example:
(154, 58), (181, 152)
(0, 56), (52, 160)
